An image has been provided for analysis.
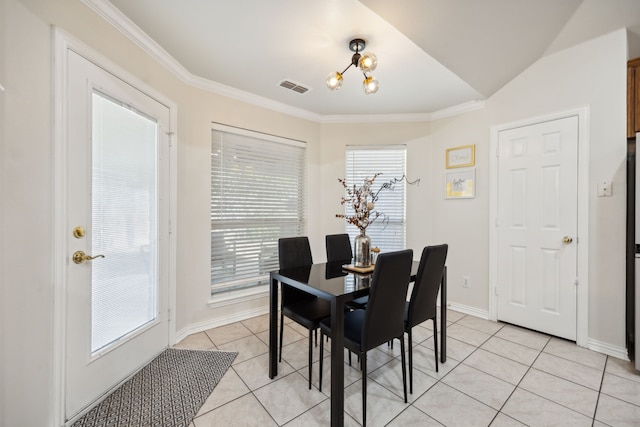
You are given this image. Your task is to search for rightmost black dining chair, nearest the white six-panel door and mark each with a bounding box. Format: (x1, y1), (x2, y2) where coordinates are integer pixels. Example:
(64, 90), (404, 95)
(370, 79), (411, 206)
(404, 244), (449, 394)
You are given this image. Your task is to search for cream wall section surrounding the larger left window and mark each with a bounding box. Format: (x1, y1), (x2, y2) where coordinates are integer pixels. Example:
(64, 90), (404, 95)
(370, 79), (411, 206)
(176, 90), (320, 331)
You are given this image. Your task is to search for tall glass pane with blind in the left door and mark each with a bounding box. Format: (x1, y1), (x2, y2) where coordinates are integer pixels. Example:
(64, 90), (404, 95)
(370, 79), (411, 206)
(90, 92), (158, 353)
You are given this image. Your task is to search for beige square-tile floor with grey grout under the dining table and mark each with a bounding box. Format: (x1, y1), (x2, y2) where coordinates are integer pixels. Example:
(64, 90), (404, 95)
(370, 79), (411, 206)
(176, 310), (640, 427)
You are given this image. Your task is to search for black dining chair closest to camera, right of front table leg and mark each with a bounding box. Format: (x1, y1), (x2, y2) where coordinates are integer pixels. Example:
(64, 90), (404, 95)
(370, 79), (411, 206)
(320, 249), (413, 427)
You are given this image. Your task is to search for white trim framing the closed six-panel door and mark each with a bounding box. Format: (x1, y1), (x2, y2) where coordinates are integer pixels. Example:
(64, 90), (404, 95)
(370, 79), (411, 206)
(489, 105), (590, 347)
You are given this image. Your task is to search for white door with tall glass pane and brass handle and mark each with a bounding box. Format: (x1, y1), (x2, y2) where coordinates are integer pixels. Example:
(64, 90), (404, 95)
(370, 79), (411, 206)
(65, 52), (169, 420)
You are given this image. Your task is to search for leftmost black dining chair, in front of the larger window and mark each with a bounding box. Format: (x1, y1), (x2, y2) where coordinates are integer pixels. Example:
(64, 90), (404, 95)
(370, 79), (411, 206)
(278, 236), (331, 389)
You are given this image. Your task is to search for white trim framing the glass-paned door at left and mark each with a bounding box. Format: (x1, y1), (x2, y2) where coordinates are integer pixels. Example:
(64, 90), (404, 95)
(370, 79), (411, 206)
(50, 27), (178, 426)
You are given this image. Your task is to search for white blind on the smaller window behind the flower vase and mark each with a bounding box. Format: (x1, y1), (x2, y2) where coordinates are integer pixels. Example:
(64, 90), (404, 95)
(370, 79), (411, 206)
(345, 145), (407, 252)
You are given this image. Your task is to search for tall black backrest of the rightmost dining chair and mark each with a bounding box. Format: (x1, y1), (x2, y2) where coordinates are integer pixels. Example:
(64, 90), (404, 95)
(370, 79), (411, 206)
(405, 244), (449, 327)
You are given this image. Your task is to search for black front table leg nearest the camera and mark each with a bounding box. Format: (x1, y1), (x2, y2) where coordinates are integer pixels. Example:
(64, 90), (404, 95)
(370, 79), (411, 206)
(331, 299), (344, 427)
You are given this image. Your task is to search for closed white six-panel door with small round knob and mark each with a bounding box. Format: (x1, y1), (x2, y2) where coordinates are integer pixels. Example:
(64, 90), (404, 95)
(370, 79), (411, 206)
(497, 116), (578, 340)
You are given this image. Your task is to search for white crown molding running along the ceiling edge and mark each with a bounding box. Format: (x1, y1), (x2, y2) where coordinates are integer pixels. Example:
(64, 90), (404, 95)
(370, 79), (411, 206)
(81, 0), (484, 123)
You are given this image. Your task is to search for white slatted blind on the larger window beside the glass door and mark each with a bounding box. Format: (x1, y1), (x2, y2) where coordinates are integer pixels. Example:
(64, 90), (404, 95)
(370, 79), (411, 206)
(211, 125), (306, 294)
